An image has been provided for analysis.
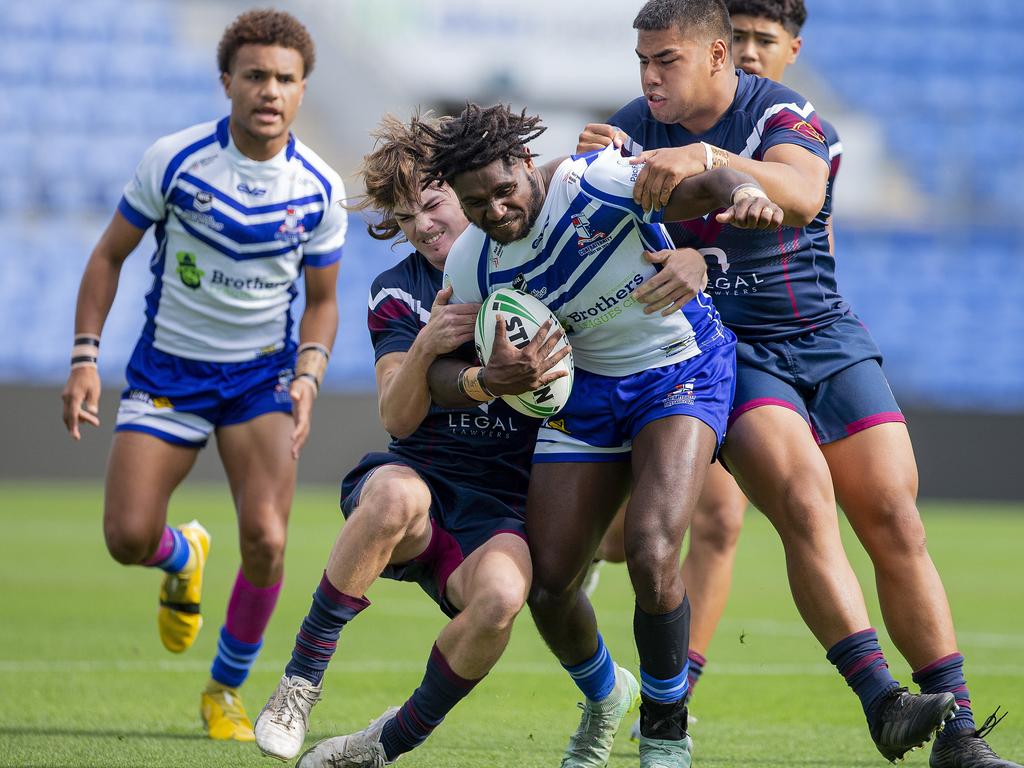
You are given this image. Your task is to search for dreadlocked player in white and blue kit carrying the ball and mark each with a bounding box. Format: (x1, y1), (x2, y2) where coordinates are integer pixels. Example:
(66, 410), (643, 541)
(419, 104), (782, 768)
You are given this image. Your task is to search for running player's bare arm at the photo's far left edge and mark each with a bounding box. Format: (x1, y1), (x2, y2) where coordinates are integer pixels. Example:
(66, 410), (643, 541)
(60, 213), (145, 440)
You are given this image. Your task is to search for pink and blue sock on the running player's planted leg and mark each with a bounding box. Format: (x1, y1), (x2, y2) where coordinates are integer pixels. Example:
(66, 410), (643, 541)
(210, 568), (281, 688)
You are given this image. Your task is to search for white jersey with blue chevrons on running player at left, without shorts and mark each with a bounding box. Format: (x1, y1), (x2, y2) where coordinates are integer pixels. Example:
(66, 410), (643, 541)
(118, 118), (347, 362)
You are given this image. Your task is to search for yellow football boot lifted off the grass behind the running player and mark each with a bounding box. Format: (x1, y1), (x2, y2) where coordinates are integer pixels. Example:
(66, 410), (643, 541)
(157, 520), (210, 653)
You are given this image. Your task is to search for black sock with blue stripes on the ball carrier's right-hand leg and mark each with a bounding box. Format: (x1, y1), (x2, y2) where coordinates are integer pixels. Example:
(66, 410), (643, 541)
(633, 595), (690, 705)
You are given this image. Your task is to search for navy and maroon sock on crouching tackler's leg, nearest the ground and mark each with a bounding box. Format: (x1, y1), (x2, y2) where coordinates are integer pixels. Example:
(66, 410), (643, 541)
(381, 645), (482, 762)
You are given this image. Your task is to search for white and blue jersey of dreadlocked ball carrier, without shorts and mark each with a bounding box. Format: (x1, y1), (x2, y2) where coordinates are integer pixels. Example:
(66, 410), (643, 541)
(444, 146), (729, 376)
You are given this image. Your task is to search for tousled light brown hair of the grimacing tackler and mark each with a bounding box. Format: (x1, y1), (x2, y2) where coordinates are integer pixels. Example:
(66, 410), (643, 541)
(345, 113), (437, 243)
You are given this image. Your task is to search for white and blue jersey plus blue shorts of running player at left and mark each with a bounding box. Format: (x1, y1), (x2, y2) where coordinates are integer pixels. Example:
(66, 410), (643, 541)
(111, 118), (346, 446)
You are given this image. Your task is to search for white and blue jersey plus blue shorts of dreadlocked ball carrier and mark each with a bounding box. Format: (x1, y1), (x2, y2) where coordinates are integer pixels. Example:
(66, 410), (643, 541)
(445, 146), (735, 463)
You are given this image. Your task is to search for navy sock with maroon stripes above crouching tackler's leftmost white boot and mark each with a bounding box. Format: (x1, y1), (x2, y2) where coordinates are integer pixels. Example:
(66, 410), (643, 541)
(285, 571), (370, 684)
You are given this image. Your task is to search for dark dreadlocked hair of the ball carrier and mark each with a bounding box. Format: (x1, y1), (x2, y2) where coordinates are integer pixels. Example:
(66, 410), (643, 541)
(413, 102), (548, 185)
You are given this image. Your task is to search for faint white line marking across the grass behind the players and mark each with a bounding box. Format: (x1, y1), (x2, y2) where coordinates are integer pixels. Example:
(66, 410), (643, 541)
(0, 658), (1024, 678)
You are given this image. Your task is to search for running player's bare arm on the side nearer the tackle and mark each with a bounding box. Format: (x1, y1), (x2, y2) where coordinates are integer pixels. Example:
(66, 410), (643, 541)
(289, 262), (338, 459)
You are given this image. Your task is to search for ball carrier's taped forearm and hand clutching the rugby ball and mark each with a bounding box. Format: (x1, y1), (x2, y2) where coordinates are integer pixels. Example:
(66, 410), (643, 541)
(429, 315), (571, 408)
